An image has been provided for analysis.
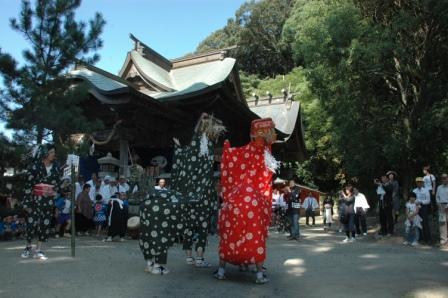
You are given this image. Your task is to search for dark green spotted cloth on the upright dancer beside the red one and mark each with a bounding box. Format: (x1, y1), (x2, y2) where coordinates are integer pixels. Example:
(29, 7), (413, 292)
(171, 133), (217, 251)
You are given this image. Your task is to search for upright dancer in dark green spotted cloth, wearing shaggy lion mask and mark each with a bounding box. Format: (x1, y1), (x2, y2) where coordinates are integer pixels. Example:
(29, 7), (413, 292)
(171, 113), (225, 268)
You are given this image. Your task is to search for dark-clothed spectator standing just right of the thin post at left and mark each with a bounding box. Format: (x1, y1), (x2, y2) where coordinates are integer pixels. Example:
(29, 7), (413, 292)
(75, 184), (93, 236)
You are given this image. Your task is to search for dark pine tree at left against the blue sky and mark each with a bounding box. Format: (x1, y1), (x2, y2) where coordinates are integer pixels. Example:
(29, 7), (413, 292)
(0, 0), (105, 143)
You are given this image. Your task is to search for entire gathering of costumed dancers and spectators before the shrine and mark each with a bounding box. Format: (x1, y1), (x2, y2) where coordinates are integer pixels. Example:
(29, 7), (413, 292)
(6, 130), (448, 283)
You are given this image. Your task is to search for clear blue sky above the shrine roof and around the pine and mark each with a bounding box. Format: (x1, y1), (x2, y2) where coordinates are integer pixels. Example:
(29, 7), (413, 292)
(0, 0), (245, 135)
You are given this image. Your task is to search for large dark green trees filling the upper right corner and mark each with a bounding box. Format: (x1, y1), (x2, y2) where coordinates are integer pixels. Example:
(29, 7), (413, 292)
(284, 0), (448, 191)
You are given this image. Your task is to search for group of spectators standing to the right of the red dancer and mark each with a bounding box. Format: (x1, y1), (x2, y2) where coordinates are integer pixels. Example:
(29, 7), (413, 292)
(271, 166), (448, 246)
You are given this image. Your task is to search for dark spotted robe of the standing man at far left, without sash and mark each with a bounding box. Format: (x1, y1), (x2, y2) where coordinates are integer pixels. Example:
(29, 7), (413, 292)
(23, 160), (61, 242)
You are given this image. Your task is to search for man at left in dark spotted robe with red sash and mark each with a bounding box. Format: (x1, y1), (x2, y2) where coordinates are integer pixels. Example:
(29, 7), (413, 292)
(21, 144), (62, 260)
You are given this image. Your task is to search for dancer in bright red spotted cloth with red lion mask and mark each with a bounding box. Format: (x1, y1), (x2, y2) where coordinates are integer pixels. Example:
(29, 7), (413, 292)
(214, 118), (279, 284)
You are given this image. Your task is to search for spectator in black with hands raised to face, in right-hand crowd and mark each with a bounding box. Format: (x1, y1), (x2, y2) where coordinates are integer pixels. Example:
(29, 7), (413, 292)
(374, 175), (394, 236)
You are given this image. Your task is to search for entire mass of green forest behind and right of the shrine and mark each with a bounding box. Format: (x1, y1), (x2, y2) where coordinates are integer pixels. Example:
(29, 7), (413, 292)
(197, 0), (448, 194)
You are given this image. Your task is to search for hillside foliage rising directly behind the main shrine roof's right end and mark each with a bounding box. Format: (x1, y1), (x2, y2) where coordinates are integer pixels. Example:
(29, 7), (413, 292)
(197, 0), (294, 77)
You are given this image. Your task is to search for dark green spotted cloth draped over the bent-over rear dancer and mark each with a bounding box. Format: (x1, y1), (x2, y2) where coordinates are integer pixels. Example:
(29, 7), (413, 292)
(139, 190), (187, 264)
